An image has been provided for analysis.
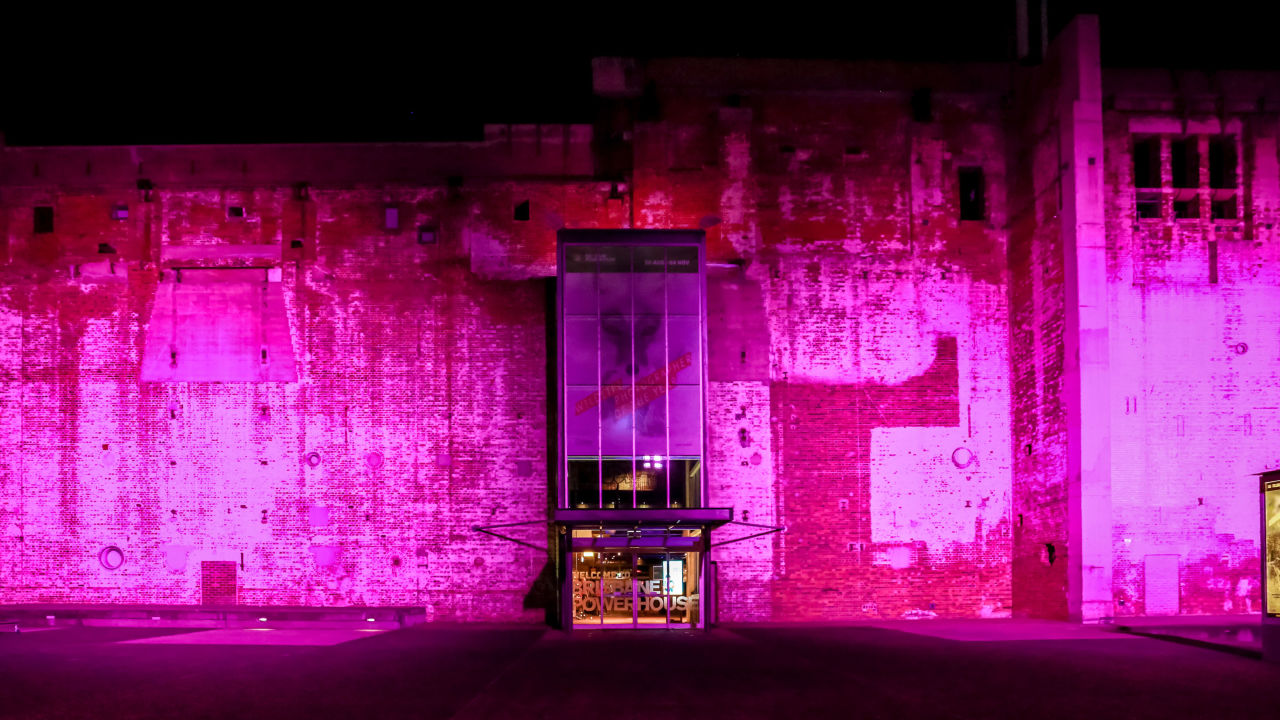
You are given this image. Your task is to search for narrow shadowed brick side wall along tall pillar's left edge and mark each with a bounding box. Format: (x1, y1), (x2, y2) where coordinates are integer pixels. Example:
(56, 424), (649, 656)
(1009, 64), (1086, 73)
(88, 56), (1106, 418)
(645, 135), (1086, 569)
(1009, 51), (1071, 619)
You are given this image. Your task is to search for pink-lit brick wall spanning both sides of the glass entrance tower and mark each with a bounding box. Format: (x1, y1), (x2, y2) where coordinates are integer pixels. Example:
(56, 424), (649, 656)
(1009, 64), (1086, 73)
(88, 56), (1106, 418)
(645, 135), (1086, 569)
(0, 63), (1024, 621)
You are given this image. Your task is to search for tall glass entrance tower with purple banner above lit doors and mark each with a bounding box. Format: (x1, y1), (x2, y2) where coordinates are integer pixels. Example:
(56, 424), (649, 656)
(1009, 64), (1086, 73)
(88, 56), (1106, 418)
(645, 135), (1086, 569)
(554, 231), (732, 629)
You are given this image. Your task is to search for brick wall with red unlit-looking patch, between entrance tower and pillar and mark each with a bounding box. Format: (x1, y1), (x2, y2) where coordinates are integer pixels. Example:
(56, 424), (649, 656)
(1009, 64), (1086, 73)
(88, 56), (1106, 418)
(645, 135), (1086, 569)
(635, 70), (1012, 621)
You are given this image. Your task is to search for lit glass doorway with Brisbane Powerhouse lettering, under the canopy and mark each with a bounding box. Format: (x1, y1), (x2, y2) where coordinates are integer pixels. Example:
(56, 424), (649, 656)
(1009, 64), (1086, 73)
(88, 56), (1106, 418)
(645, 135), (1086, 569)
(573, 548), (701, 629)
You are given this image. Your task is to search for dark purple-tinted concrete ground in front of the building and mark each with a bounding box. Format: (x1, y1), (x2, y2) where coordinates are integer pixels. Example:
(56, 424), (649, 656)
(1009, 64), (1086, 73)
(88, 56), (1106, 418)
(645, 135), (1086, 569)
(0, 620), (1280, 720)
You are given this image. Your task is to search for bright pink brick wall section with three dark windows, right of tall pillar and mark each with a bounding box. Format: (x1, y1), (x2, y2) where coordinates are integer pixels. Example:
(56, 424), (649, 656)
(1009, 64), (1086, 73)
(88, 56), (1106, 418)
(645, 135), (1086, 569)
(1106, 109), (1280, 615)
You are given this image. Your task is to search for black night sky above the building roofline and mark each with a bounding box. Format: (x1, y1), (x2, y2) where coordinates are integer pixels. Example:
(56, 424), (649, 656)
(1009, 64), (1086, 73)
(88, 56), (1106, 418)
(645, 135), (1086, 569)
(0, 0), (1280, 145)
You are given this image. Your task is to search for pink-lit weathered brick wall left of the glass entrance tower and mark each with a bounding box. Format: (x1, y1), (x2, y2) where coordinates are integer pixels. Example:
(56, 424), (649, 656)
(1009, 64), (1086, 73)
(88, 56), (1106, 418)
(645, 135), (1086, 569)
(0, 159), (611, 621)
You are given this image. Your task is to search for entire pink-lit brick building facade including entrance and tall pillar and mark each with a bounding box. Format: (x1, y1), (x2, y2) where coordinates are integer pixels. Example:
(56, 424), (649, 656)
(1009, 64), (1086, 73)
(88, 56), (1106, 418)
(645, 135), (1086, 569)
(0, 17), (1280, 626)
